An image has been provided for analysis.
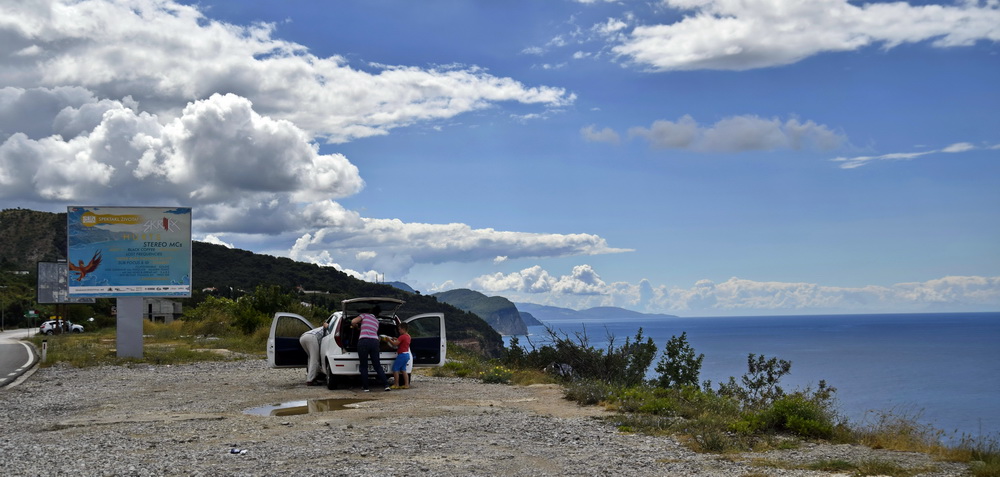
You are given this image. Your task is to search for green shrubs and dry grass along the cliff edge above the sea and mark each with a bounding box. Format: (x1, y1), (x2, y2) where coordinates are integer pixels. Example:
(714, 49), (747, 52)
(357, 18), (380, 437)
(434, 329), (1000, 477)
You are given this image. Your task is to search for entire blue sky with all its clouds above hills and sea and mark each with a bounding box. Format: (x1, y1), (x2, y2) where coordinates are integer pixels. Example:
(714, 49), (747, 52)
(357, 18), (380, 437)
(0, 0), (1000, 316)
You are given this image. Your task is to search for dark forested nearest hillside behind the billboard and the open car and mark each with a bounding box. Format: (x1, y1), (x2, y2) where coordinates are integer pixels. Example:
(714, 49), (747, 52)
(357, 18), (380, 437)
(0, 209), (503, 355)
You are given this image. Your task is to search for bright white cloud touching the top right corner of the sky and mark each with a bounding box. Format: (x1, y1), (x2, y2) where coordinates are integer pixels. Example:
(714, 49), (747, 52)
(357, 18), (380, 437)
(613, 0), (1000, 71)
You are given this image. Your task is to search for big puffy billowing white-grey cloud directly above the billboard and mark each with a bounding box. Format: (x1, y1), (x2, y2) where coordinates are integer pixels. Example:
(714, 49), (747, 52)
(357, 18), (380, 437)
(0, 87), (364, 233)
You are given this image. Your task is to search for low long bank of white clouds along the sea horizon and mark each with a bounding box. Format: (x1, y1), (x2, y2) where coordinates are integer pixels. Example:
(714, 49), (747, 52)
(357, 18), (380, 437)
(468, 265), (1000, 316)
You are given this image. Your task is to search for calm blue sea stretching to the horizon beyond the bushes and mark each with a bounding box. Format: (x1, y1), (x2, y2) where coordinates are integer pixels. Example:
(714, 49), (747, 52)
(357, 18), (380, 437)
(505, 313), (1000, 440)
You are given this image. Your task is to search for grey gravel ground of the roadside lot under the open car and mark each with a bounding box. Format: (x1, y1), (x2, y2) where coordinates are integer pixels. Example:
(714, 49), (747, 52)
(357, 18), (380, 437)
(0, 359), (966, 476)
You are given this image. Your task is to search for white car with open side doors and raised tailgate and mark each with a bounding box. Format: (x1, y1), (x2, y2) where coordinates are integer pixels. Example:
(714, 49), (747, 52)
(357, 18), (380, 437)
(267, 297), (446, 389)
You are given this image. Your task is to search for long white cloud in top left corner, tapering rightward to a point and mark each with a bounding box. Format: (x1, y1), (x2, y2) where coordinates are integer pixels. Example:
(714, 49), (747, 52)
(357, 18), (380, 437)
(0, 0), (575, 142)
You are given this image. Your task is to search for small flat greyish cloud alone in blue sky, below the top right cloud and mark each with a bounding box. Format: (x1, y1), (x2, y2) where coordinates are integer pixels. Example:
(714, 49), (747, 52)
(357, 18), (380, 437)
(624, 115), (847, 152)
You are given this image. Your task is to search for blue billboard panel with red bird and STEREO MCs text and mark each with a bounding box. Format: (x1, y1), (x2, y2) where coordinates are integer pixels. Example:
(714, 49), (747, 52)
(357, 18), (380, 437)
(66, 207), (191, 298)
